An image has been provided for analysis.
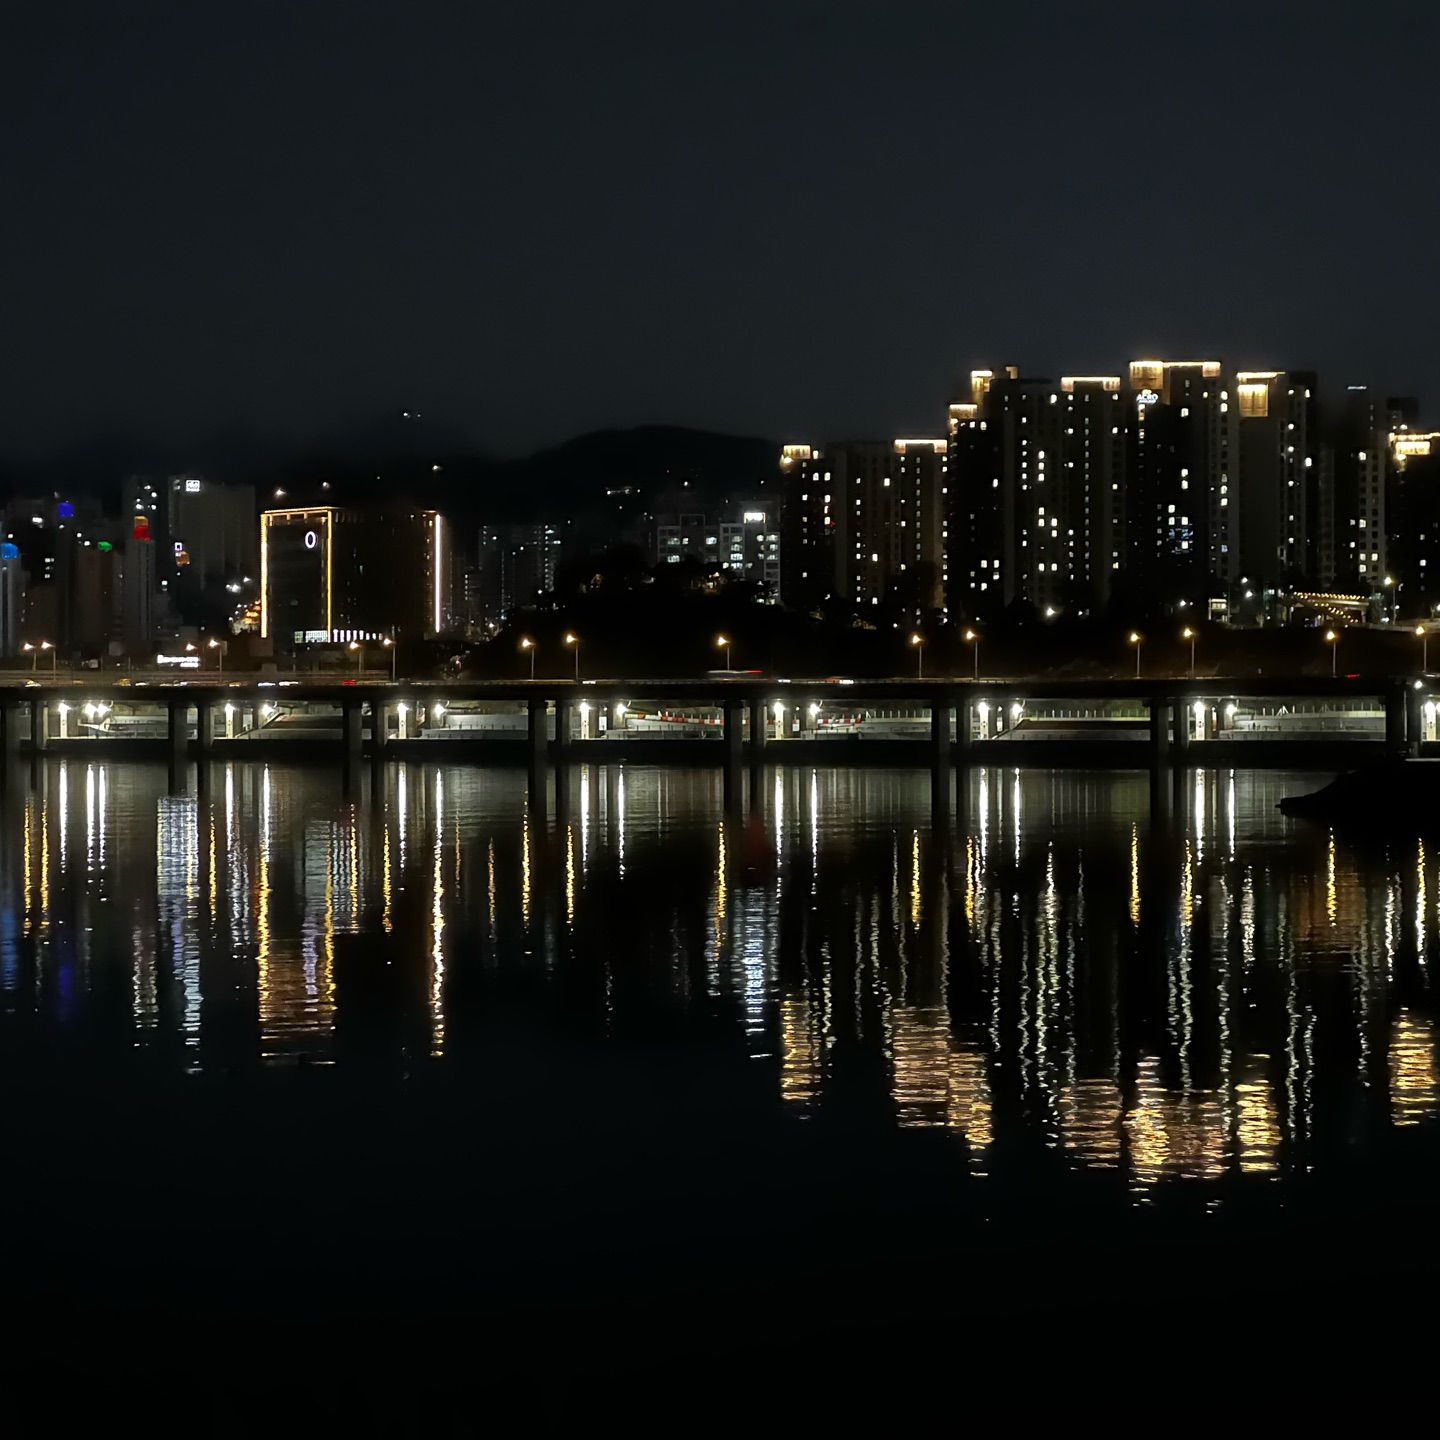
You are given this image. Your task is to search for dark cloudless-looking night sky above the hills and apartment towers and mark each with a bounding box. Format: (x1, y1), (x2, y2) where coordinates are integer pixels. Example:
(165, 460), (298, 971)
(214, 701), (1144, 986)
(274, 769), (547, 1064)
(0, 0), (1440, 456)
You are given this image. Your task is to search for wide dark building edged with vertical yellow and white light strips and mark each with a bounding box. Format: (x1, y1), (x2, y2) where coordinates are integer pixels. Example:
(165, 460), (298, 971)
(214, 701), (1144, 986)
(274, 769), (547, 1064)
(261, 505), (458, 649)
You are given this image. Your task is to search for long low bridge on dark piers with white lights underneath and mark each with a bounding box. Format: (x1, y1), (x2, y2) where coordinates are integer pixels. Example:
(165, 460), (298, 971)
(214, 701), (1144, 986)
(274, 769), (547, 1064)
(0, 675), (1422, 768)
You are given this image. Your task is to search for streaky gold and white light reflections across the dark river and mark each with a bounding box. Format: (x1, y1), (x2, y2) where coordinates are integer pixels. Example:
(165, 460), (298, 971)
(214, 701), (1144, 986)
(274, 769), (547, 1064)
(0, 762), (1440, 1202)
